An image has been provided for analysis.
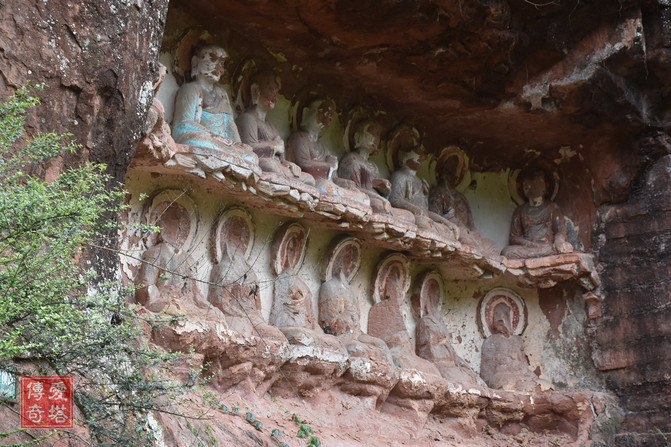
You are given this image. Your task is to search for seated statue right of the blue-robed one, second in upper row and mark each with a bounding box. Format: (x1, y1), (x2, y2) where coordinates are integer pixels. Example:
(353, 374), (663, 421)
(236, 72), (315, 185)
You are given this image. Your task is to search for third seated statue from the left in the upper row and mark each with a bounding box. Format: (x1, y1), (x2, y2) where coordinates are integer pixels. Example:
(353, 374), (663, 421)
(287, 99), (338, 180)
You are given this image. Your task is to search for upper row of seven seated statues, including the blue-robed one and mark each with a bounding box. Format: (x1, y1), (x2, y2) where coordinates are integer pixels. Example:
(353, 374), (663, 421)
(167, 45), (573, 258)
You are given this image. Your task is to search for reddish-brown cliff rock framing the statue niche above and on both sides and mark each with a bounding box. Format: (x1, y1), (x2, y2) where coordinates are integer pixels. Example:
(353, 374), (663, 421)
(0, 0), (671, 445)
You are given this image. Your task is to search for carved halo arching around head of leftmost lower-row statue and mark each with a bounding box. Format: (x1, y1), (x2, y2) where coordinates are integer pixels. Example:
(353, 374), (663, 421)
(145, 189), (199, 250)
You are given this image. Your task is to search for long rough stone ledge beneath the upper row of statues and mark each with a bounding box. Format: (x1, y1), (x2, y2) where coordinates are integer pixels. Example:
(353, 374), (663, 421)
(130, 143), (600, 291)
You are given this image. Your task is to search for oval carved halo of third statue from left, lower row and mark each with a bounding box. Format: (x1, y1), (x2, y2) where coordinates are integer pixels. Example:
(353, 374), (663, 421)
(270, 222), (308, 275)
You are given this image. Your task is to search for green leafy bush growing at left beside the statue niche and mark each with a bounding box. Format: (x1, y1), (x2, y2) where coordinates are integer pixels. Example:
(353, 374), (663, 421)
(0, 88), (189, 445)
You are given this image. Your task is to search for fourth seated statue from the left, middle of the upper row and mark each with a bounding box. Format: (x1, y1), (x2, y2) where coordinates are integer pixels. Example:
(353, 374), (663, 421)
(334, 120), (391, 213)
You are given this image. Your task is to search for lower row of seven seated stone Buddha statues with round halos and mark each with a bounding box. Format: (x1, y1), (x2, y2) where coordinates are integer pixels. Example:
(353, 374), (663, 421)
(135, 192), (542, 392)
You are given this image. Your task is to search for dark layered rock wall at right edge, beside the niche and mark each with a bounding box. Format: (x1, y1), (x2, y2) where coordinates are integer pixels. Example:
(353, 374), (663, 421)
(594, 138), (671, 445)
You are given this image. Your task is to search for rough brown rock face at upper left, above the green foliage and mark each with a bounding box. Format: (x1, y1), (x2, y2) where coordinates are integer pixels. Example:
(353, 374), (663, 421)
(0, 0), (168, 279)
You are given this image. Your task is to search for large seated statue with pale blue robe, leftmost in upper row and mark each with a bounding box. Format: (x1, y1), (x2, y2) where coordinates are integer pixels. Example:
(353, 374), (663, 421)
(172, 45), (256, 161)
